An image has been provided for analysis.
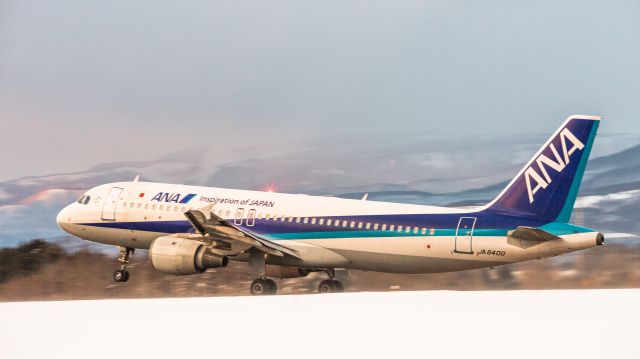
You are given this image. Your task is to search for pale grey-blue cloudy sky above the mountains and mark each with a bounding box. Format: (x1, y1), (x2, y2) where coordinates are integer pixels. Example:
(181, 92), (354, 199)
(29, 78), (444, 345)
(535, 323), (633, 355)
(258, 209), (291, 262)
(0, 0), (640, 180)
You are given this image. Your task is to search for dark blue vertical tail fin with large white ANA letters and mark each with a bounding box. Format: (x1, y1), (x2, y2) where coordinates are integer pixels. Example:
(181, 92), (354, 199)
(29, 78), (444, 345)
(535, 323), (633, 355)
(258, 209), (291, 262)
(485, 115), (600, 223)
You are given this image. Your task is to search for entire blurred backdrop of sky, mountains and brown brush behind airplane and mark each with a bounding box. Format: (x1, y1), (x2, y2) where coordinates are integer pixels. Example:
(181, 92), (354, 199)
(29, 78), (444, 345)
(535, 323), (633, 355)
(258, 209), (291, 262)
(0, 0), (640, 300)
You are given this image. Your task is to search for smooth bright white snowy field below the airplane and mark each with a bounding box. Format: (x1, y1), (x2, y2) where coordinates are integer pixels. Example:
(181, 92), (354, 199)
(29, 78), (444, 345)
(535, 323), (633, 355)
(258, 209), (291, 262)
(0, 289), (640, 359)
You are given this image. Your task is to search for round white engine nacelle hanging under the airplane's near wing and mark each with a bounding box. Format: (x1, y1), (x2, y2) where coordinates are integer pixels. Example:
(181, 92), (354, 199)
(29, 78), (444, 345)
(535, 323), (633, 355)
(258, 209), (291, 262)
(149, 237), (229, 275)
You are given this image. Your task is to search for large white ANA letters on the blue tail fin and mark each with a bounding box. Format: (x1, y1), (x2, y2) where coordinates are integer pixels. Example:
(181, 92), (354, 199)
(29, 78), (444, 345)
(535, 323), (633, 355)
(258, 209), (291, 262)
(524, 128), (584, 204)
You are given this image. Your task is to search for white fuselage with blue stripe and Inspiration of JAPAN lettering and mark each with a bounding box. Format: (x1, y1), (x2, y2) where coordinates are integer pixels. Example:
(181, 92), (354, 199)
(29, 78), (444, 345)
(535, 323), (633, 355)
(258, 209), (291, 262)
(57, 182), (597, 273)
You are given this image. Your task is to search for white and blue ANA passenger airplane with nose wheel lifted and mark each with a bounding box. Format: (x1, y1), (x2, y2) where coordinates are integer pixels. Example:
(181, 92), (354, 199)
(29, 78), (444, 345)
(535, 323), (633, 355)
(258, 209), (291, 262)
(56, 115), (604, 295)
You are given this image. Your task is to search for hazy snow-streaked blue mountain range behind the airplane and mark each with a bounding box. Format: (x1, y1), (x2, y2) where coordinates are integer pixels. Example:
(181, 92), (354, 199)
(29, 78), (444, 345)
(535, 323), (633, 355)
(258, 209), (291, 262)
(0, 134), (640, 246)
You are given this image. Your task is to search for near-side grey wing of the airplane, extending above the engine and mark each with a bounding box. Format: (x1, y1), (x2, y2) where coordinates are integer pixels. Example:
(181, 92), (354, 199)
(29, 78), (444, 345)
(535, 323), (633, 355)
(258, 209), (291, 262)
(184, 204), (300, 258)
